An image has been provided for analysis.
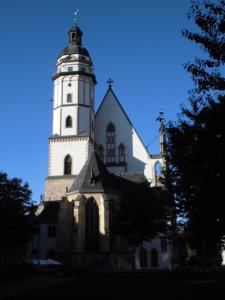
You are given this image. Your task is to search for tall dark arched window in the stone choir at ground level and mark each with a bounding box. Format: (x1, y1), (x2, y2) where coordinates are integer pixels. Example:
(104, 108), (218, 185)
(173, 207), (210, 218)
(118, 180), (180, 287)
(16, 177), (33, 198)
(85, 198), (99, 251)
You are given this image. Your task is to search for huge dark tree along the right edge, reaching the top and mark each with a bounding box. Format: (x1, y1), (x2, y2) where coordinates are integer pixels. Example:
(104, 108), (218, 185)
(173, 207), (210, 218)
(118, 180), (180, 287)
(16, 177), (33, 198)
(165, 0), (225, 265)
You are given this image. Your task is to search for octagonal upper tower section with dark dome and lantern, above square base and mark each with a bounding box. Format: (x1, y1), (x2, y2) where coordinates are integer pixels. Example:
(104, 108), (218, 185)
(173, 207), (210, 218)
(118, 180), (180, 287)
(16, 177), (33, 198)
(52, 26), (96, 138)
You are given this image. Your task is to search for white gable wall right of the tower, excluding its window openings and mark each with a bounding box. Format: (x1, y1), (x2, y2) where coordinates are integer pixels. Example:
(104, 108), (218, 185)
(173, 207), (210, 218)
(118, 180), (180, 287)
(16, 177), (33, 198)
(95, 88), (163, 185)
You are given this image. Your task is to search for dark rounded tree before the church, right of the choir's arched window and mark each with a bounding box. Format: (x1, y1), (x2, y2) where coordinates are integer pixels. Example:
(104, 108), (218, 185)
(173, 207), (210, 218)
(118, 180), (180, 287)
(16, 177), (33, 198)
(112, 182), (167, 246)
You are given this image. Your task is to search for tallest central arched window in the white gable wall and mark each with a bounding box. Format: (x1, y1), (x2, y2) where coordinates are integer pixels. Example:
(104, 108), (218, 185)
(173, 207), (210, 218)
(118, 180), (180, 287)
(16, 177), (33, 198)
(106, 122), (116, 163)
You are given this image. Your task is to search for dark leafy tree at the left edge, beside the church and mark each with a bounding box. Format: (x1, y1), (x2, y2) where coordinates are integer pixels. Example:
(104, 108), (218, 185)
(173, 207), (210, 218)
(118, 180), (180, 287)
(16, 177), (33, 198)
(0, 173), (36, 256)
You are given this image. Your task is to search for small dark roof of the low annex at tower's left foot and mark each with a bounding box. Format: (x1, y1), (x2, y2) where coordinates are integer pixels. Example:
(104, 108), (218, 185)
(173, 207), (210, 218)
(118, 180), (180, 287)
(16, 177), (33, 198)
(37, 201), (60, 224)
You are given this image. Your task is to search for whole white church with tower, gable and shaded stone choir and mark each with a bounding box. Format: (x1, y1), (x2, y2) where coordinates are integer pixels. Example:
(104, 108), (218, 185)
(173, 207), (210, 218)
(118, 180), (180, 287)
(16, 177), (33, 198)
(32, 25), (171, 269)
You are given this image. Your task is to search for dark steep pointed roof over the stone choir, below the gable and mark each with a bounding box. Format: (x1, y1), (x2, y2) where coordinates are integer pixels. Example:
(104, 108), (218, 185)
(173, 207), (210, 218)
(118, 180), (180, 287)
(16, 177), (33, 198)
(69, 151), (116, 193)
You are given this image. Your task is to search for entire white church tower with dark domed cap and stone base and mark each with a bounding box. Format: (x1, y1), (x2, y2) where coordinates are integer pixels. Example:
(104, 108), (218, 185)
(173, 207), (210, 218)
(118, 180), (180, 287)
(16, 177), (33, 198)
(44, 25), (96, 200)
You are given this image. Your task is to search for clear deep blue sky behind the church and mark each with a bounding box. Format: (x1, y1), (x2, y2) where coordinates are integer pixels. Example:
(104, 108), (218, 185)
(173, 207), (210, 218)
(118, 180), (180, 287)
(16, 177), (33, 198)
(0, 0), (200, 201)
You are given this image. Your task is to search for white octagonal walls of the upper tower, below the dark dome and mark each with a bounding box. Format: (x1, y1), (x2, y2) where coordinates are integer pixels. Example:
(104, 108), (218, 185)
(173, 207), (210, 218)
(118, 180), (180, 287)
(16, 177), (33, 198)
(53, 59), (94, 137)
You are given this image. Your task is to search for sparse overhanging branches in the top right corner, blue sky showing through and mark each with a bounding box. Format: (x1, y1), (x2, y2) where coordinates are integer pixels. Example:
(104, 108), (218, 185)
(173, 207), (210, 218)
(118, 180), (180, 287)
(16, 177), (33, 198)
(183, 0), (225, 105)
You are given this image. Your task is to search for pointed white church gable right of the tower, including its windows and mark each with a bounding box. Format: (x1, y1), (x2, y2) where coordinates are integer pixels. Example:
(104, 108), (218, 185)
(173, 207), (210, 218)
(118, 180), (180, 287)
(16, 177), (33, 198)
(95, 88), (151, 179)
